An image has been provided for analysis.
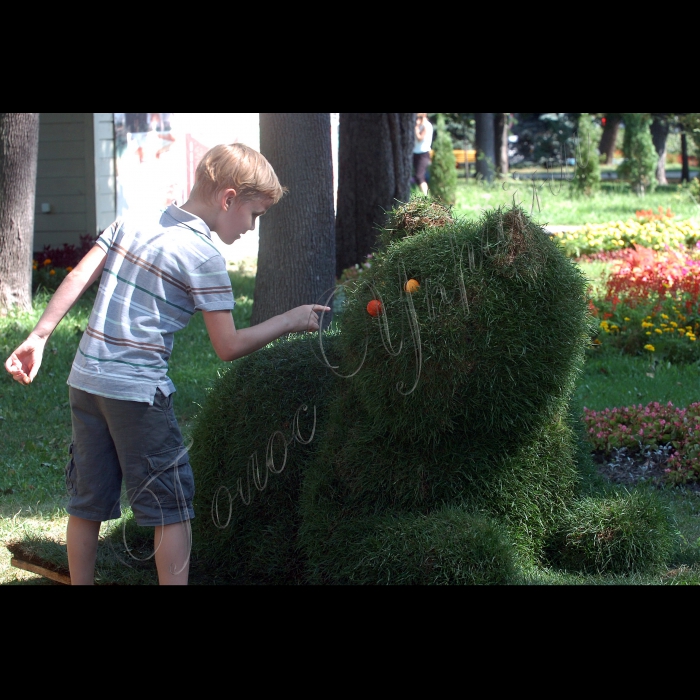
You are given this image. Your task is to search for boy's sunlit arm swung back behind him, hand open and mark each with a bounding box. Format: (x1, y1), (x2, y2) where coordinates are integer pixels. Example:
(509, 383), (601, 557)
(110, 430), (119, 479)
(5, 245), (107, 384)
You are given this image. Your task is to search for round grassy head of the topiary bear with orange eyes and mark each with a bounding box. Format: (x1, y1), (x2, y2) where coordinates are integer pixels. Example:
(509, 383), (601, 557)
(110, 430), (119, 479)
(326, 198), (590, 440)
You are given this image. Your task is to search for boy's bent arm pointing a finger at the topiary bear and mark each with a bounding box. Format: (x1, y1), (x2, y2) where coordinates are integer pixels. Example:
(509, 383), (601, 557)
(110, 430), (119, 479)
(202, 304), (331, 362)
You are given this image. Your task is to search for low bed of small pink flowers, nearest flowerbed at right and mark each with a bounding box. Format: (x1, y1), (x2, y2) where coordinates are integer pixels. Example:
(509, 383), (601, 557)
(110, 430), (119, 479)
(583, 401), (700, 484)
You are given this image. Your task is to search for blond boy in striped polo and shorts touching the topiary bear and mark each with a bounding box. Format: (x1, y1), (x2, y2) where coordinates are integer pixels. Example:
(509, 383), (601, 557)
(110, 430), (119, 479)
(5, 144), (330, 585)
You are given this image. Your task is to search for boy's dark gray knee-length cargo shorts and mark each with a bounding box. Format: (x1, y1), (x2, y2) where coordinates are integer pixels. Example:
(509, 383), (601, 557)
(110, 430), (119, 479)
(66, 387), (194, 526)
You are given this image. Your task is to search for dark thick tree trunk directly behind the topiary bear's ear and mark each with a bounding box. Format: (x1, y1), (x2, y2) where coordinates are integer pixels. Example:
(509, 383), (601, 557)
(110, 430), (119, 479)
(335, 112), (416, 277)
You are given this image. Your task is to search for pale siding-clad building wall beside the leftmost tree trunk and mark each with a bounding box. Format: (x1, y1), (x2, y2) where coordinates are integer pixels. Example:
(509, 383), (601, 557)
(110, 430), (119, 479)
(34, 112), (115, 251)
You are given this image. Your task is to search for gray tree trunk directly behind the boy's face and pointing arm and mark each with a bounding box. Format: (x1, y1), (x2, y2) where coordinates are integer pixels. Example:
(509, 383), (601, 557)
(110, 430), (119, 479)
(251, 112), (335, 327)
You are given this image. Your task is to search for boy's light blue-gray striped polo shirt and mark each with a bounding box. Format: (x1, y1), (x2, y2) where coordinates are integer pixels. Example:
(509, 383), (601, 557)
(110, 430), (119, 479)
(68, 204), (235, 404)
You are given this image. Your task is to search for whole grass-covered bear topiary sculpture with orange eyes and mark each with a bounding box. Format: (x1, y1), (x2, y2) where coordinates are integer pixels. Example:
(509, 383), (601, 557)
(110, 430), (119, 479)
(190, 197), (671, 584)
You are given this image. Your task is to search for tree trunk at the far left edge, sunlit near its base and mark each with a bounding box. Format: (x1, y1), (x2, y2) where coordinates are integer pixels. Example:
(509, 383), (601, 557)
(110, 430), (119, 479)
(0, 112), (39, 315)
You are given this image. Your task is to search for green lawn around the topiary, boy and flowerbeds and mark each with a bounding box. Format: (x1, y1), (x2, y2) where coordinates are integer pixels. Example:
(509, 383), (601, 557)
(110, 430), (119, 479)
(0, 180), (700, 585)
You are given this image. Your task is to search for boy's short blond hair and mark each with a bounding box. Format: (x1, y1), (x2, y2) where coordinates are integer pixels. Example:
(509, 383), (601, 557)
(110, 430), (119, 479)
(190, 143), (287, 204)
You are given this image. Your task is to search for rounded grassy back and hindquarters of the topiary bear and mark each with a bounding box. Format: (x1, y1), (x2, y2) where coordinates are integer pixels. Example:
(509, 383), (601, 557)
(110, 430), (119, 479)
(190, 334), (336, 583)
